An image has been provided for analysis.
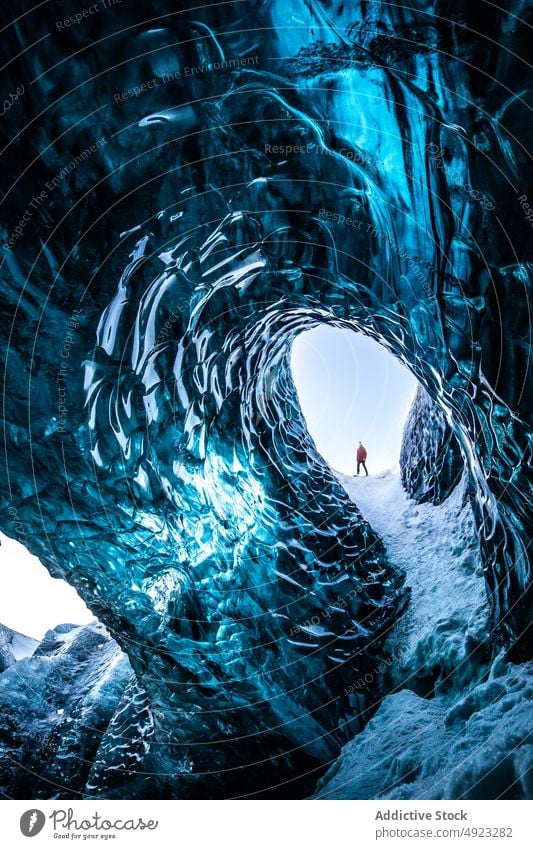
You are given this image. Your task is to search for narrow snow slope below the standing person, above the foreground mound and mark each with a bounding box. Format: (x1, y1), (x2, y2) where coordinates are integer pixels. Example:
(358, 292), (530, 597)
(338, 470), (488, 682)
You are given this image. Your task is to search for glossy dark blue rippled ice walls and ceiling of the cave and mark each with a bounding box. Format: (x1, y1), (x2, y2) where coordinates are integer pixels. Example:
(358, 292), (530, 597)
(0, 0), (531, 798)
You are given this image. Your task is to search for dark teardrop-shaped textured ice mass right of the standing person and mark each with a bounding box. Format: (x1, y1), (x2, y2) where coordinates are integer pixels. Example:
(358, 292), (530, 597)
(400, 386), (464, 504)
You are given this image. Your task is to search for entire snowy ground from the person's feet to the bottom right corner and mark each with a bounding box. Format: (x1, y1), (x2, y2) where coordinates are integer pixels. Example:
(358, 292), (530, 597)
(316, 472), (533, 799)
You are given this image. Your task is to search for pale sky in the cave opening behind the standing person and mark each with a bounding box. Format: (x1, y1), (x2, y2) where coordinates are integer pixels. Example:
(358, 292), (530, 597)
(291, 324), (417, 475)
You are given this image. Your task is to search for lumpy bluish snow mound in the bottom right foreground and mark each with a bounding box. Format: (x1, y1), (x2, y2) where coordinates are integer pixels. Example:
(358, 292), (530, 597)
(315, 658), (533, 799)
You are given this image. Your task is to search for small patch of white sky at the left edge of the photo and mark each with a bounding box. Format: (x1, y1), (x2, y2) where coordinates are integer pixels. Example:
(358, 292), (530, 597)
(0, 534), (94, 640)
